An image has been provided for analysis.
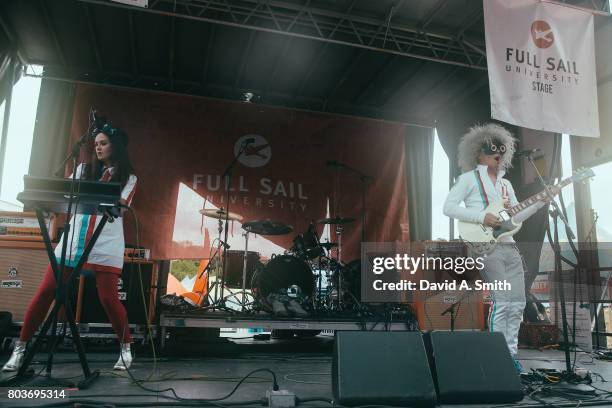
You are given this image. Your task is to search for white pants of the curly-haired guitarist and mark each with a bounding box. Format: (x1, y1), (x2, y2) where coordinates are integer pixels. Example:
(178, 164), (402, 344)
(482, 243), (525, 357)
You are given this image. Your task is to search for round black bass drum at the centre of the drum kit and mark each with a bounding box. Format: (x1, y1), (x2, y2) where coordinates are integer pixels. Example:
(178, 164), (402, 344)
(254, 255), (315, 300)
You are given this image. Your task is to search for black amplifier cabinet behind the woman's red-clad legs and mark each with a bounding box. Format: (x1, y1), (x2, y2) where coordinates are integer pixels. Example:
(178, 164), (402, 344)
(73, 262), (155, 324)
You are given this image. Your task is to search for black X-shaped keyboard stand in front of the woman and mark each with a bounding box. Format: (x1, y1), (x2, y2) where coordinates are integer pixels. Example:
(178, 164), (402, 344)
(0, 209), (114, 389)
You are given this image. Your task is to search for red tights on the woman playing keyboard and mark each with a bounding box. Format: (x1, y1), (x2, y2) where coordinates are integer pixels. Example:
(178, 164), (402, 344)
(19, 265), (132, 343)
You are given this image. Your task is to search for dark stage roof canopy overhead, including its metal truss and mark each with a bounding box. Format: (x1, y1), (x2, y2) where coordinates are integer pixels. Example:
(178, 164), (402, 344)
(0, 0), (502, 126)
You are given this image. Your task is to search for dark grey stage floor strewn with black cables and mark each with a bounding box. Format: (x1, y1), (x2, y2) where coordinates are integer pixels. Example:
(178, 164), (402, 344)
(0, 334), (612, 408)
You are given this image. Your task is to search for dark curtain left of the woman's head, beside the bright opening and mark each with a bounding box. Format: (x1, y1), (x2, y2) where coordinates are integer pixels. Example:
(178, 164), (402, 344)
(29, 79), (76, 177)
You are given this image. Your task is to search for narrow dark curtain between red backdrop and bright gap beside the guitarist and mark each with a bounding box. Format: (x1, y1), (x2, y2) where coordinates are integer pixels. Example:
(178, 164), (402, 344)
(405, 126), (434, 241)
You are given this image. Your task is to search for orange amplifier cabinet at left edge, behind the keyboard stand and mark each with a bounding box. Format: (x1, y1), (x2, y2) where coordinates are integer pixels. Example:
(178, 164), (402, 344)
(0, 241), (49, 323)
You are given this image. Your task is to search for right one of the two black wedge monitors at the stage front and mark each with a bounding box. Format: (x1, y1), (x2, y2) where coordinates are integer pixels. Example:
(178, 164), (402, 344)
(428, 331), (523, 404)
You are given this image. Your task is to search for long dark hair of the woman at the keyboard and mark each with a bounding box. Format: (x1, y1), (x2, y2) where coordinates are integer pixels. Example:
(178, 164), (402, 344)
(85, 123), (134, 187)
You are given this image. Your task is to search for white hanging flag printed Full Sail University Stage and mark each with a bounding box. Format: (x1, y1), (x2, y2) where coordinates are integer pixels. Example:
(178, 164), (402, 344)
(483, 0), (599, 137)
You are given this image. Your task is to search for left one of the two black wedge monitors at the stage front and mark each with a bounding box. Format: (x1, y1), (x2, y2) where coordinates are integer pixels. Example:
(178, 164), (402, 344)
(332, 331), (436, 407)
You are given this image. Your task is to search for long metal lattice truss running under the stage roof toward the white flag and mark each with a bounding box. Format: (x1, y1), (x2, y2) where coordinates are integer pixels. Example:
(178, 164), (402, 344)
(79, 0), (486, 71)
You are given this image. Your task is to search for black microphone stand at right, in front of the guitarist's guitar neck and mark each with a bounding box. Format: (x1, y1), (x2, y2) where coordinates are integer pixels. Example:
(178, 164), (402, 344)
(526, 154), (595, 392)
